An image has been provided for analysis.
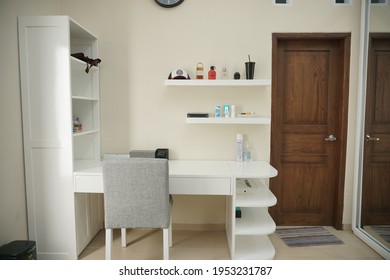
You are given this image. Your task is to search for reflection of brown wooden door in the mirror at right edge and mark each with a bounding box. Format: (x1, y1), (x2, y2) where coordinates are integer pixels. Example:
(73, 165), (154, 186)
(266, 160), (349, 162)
(361, 33), (390, 226)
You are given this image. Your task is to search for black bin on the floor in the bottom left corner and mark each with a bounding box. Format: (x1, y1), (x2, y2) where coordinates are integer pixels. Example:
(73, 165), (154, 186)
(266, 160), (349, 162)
(0, 240), (37, 260)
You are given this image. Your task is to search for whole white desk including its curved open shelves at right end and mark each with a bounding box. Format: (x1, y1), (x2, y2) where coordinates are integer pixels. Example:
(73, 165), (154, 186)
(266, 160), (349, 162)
(74, 160), (277, 259)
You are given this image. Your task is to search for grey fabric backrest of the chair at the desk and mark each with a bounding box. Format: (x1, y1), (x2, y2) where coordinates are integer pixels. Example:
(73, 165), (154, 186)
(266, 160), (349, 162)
(103, 158), (170, 228)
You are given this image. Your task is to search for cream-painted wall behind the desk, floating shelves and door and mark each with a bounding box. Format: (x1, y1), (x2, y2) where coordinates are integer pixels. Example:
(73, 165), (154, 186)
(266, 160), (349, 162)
(0, 0), (360, 243)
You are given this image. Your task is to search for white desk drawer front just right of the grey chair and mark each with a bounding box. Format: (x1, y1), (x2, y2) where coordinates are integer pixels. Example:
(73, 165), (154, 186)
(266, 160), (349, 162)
(169, 177), (232, 195)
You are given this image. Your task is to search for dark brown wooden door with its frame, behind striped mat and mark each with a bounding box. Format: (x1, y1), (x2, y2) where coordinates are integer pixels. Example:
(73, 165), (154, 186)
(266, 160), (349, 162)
(270, 34), (350, 228)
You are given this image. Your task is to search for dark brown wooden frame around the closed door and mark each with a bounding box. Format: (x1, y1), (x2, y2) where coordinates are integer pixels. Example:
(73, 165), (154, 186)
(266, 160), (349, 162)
(270, 33), (351, 229)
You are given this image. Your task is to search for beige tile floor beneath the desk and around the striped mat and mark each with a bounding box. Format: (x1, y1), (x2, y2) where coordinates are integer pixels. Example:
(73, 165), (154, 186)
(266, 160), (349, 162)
(79, 227), (383, 260)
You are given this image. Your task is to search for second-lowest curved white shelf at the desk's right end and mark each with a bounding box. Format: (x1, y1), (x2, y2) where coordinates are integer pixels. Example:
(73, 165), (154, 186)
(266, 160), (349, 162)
(235, 207), (276, 235)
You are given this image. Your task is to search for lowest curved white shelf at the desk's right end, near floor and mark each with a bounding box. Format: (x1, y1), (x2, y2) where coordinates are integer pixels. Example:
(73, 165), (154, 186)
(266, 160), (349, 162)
(233, 235), (275, 260)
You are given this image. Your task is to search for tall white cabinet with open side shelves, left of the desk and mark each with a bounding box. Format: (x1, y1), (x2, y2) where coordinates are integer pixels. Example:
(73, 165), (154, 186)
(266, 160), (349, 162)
(18, 16), (103, 259)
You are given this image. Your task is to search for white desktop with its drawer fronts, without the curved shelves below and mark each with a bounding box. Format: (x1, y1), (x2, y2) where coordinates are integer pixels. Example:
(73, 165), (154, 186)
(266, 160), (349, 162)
(74, 160), (278, 195)
